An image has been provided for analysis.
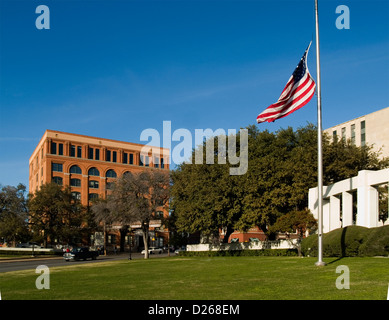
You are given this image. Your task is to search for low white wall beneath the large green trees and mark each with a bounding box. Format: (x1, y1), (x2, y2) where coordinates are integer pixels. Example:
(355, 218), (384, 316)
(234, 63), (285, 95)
(186, 239), (297, 251)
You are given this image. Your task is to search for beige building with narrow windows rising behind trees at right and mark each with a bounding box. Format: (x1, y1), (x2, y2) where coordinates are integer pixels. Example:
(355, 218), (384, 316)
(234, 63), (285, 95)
(324, 107), (389, 157)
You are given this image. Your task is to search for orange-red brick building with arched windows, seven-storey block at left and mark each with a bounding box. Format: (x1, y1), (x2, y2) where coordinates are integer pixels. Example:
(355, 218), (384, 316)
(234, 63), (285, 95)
(29, 130), (169, 250)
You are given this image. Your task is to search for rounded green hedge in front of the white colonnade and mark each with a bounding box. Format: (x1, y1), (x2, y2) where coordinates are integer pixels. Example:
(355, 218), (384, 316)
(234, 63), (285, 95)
(301, 225), (389, 257)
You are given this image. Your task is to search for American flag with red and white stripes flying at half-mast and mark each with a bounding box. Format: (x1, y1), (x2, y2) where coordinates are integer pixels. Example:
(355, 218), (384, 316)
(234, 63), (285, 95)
(257, 42), (316, 123)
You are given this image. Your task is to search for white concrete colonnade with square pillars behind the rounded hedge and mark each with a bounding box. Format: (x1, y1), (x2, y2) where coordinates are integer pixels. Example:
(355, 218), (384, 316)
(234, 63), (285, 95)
(308, 168), (389, 233)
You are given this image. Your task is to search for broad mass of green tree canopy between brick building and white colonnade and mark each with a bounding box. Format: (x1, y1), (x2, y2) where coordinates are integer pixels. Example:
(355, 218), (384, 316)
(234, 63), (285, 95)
(171, 124), (388, 241)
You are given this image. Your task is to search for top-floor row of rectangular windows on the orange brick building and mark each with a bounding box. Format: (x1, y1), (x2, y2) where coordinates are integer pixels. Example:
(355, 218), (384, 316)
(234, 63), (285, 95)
(50, 142), (165, 169)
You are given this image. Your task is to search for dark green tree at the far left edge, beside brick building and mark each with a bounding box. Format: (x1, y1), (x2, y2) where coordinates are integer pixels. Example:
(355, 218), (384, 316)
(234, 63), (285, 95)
(0, 184), (30, 245)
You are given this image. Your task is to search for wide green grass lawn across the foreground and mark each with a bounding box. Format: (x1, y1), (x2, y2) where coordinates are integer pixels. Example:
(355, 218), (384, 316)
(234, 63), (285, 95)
(0, 257), (389, 300)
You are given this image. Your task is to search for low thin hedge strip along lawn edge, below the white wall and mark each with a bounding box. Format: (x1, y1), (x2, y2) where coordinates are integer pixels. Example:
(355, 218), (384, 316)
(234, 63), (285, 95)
(180, 249), (297, 257)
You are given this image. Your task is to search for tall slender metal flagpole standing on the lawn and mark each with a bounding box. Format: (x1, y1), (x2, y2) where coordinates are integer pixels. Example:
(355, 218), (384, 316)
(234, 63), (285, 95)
(315, 0), (325, 266)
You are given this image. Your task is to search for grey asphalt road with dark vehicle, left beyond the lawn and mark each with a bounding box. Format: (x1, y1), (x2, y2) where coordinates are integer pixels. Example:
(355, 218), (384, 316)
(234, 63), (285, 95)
(0, 253), (174, 273)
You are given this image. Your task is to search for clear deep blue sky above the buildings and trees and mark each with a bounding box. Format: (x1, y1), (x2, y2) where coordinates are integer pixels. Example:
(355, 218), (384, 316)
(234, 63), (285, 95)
(0, 0), (389, 186)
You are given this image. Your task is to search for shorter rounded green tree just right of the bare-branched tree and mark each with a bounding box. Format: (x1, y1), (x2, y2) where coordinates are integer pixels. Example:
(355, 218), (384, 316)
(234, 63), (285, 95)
(171, 137), (242, 242)
